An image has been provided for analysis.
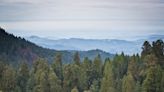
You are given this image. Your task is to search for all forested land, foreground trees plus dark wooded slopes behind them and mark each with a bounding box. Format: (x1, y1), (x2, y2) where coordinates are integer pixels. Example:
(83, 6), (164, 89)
(0, 29), (164, 92)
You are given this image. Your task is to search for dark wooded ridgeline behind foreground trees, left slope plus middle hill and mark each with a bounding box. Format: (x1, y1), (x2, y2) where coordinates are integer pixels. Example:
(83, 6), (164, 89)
(0, 28), (114, 64)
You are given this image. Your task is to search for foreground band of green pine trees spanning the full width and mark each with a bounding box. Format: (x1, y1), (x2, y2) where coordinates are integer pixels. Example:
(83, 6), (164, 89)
(0, 40), (164, 92)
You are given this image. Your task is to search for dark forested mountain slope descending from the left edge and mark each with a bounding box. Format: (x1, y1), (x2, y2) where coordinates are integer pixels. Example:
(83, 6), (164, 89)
(0, 28), (55, 63)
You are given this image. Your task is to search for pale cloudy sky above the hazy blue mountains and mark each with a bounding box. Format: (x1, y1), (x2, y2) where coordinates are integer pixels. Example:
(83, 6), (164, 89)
(0, 0), (164, 40)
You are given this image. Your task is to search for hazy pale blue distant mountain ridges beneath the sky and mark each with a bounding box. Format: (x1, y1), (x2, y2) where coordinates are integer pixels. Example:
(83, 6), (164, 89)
(26, 35), (164, 54)
